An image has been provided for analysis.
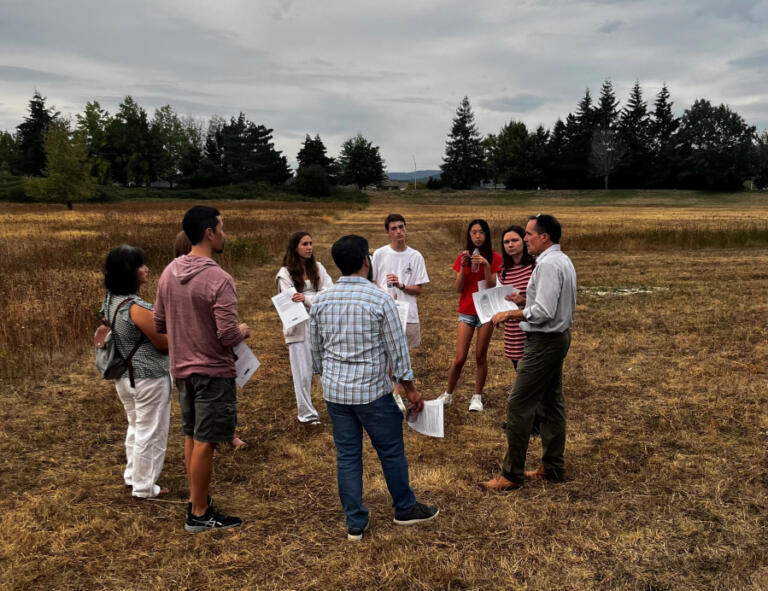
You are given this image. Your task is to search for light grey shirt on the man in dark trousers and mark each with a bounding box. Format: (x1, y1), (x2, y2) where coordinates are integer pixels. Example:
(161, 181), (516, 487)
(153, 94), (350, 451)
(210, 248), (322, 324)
(520, 244), (576, 332)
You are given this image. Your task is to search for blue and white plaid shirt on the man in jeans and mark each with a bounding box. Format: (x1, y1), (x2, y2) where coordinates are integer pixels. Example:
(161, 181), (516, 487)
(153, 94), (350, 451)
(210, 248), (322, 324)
(310, 277), (413, 404)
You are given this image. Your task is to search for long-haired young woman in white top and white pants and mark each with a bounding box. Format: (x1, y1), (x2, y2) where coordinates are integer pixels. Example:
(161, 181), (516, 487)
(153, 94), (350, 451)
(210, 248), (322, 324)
(275, 232), (333, 425)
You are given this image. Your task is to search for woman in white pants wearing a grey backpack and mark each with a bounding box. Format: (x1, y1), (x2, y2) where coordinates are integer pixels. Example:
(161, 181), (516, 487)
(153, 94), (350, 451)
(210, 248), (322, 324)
(102, 244), (171, 499)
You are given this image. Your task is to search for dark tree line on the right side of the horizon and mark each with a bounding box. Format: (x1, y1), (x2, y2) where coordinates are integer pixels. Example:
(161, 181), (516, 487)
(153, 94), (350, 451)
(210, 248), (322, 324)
(438, 80), (768, 190)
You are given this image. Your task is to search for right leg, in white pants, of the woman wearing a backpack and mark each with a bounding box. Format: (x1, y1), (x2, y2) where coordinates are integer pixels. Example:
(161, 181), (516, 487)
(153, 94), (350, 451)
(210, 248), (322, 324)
(133, 376), (171, 498)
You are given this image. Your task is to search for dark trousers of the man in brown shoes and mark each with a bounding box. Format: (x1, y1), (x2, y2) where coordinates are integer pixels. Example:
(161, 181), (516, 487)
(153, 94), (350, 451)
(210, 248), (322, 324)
(501, 330), (571, 483)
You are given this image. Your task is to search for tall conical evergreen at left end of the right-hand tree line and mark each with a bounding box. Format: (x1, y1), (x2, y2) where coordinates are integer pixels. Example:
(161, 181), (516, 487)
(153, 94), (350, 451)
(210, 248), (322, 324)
(440, 96), (486, 189)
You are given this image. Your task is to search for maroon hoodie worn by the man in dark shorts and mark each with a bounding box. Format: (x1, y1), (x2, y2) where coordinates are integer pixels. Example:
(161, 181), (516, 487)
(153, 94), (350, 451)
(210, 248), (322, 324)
(155, 255), (243, 378)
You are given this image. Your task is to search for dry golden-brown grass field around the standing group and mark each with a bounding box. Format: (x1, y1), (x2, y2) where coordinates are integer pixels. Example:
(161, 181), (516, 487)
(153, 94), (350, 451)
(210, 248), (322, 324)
(0, 194), (768, 591)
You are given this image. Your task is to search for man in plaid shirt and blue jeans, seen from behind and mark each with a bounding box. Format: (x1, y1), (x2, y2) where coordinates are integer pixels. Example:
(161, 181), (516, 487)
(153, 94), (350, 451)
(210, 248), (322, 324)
(310, 235), (438, 540)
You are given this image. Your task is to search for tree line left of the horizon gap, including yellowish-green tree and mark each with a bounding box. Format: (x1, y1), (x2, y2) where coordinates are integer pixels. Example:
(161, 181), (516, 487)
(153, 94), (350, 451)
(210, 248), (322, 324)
(0, 92), (385, 204)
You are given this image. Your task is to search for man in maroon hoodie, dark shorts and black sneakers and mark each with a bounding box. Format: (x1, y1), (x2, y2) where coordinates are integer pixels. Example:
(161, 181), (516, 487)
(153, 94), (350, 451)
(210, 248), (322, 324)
(155, 205), (249, 533)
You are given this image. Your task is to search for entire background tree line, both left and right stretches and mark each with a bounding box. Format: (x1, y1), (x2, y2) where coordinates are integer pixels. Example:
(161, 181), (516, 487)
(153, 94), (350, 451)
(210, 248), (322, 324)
(0, 80), (768, 203)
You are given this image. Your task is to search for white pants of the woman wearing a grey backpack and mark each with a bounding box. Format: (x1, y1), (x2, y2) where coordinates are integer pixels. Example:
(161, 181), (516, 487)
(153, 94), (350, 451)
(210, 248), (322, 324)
(115, 375), (171, 498)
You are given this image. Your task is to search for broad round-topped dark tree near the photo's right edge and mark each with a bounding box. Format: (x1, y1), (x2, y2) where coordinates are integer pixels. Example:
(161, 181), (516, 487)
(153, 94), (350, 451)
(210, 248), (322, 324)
(672, 99), (757, 191)
